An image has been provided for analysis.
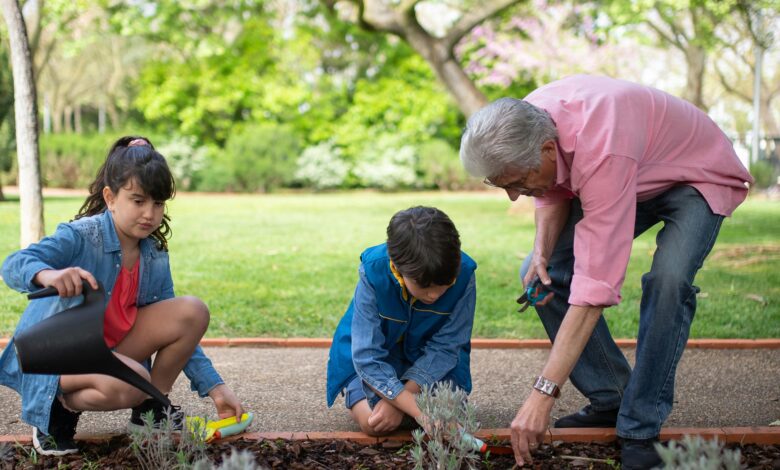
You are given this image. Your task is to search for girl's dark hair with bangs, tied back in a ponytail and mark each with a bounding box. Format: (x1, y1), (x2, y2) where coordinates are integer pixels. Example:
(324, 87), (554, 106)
(75, 136), (176, 251)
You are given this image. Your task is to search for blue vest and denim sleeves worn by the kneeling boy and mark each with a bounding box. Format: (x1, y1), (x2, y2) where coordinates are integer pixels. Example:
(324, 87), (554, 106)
(327, 244), (477, 406)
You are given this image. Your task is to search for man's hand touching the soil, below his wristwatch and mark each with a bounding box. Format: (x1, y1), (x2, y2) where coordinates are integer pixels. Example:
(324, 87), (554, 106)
(511, 390), (555, 467)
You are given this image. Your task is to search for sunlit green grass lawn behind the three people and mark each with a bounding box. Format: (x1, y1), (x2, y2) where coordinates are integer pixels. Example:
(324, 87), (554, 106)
(0, 191), (780, 338)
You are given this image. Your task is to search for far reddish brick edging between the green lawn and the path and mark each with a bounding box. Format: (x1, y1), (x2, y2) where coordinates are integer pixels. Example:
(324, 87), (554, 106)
(0, 338), (780, 349)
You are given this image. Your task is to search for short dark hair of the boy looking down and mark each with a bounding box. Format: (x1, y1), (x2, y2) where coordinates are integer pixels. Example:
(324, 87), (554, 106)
(387, 206), (460, 288)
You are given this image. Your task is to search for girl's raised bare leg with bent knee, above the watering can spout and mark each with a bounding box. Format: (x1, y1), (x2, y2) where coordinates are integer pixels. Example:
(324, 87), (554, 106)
(116, 296), (209, 394)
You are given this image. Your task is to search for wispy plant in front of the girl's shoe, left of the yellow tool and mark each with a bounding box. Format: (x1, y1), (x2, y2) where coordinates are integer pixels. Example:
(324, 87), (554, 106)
(130, 411), (206, 470)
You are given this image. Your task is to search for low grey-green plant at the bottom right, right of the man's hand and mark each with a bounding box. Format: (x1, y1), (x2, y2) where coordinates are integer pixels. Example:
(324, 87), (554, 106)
(655, 435), (741, 470)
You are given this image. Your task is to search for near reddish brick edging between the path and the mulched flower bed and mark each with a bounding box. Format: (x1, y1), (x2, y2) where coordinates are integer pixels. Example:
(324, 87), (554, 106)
(0, 426), (780, 445)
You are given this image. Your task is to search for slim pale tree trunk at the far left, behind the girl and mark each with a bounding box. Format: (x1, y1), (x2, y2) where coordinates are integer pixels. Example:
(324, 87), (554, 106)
(0, 0), (44, 248)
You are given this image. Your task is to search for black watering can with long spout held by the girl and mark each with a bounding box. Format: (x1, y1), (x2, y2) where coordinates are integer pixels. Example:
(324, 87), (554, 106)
(14, 281), (171, 406)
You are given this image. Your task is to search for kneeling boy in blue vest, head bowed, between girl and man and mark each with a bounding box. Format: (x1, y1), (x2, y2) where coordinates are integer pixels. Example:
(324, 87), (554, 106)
(327, 206), (477, 436)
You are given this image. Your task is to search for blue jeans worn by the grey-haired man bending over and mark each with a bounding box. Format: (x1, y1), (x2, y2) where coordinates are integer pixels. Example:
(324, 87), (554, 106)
(520, 186), (723, 439)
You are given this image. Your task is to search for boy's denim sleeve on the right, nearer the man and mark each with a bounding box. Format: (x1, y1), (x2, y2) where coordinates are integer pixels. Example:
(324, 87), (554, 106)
(401, 274), (477, 387)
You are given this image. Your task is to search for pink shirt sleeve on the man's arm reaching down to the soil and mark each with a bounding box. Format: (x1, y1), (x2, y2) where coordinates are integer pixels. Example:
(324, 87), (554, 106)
(569, 155), (637, 306)
